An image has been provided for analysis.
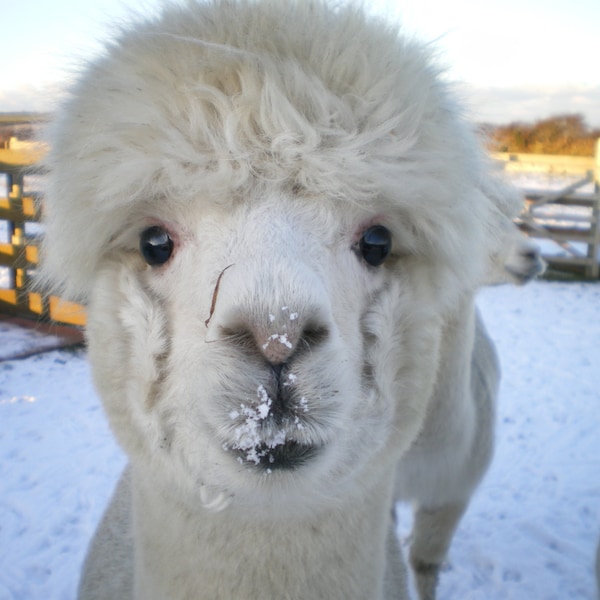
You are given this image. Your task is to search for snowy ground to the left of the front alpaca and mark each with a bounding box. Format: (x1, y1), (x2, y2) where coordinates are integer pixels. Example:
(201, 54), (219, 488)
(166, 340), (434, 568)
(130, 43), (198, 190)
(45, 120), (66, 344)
(0, 346), (125, 600)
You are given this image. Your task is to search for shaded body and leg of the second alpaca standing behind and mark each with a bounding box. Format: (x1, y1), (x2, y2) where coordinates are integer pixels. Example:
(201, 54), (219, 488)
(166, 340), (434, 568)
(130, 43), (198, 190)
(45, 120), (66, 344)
(396, 311), (500, 599)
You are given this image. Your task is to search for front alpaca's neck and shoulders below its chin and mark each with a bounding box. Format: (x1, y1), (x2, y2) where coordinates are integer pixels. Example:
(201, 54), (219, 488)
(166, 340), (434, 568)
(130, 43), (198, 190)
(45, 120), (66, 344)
(79, 470), (405, 600)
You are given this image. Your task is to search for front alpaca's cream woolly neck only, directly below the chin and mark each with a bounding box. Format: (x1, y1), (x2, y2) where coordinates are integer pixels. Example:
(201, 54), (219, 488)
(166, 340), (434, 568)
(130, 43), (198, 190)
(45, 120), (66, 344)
(134, 468), (391, 600)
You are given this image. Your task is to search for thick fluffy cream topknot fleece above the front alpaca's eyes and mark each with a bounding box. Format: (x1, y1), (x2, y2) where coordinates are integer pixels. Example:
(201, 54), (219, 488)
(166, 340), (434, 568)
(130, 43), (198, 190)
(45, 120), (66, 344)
(45, 2), (518, 299)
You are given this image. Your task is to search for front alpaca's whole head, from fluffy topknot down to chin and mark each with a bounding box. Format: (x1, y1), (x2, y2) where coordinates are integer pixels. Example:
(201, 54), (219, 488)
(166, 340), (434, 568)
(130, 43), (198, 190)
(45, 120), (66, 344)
(39, 1), (516, 514)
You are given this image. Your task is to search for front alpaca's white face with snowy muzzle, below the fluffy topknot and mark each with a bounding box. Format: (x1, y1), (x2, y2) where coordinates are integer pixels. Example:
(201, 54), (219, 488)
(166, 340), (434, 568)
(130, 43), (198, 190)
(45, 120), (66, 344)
(88, 188), (448, 514)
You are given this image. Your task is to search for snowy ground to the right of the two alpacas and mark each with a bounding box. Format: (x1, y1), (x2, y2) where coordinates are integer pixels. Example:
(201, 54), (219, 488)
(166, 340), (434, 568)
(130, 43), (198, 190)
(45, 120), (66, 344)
(408, 281), (600, 600)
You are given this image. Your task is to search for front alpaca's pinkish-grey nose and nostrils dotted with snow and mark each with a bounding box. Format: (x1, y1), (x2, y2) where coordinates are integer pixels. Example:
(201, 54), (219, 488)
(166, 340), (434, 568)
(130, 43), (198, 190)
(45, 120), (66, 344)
(221, 306), (329, 366)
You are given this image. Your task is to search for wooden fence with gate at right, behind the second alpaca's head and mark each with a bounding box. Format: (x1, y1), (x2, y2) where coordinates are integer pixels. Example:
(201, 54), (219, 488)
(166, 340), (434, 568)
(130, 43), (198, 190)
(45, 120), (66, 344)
(493, 140), (600, 279)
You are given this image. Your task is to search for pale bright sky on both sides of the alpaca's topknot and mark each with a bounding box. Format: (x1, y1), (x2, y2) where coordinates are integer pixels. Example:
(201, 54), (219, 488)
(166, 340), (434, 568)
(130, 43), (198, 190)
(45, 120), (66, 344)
(0, 0), (600, 126)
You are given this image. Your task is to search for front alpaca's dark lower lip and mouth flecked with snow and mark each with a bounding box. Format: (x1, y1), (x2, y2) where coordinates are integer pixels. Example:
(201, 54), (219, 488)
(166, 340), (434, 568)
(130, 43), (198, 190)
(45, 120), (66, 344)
(236, 440), (320, 473)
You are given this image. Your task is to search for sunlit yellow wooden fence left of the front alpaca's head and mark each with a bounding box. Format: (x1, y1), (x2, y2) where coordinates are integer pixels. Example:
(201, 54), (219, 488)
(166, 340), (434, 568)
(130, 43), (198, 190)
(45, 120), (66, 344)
(0, 117), (85, 325)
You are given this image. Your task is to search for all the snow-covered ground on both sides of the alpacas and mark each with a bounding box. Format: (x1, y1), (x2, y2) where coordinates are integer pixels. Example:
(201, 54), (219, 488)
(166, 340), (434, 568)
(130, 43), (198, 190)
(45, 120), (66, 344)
(0, 281), (600, 600)
